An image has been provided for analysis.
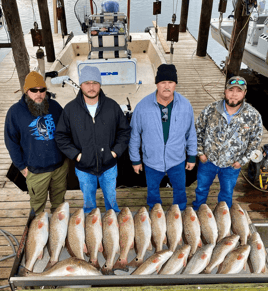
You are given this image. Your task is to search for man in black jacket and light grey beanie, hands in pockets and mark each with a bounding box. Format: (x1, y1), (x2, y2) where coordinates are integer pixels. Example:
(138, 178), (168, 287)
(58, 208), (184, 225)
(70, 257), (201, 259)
(55, 66), (130, 213)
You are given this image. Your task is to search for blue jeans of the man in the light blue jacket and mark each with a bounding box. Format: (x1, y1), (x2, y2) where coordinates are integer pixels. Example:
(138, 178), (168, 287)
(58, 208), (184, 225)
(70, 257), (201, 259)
(144, 161), (187, 210)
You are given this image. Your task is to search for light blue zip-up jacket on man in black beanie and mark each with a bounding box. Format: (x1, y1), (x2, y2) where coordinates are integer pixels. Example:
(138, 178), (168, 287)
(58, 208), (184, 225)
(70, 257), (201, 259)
(129, 91), (197, 172)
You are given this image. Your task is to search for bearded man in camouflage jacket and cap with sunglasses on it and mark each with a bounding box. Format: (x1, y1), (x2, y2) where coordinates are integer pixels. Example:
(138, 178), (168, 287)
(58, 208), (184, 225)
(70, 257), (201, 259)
(193, 76), (263, 210)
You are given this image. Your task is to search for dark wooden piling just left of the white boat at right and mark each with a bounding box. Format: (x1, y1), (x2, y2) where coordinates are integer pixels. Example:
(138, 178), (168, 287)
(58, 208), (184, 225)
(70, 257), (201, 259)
(196, 0), (213, 57)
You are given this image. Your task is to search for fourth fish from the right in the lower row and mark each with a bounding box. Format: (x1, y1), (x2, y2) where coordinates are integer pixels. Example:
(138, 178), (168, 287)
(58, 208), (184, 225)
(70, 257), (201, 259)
(182, 244), (215, 275)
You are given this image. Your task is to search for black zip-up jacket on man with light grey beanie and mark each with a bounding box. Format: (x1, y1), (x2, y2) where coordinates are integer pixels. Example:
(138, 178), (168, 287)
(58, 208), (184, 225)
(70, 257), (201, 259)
(55, 90), (130, 175)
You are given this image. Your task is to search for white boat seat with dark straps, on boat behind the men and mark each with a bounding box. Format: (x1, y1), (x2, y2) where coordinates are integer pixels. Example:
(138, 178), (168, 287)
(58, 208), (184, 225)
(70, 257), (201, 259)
(85, 13), (131, 59)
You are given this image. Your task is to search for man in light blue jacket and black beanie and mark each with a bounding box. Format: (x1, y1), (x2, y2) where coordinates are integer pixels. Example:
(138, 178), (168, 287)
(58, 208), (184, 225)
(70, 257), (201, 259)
(129, 64), (197, 210)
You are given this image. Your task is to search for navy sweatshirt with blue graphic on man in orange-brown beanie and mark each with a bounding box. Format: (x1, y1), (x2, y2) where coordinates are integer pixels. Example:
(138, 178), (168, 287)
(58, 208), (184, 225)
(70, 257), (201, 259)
(5, 92), (64, 174)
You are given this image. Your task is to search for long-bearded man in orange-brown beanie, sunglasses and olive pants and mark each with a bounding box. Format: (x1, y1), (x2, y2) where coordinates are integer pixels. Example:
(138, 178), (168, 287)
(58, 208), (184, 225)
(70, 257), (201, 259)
(5, 71), (68, 214)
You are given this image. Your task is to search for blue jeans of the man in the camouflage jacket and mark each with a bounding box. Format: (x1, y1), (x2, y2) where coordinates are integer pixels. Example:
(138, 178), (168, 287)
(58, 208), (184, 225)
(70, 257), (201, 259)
(193, 161), (240, 210)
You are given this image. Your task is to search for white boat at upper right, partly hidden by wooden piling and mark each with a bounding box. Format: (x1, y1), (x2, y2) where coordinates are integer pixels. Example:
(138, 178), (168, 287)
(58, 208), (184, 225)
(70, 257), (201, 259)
(210, 0), (268, 77)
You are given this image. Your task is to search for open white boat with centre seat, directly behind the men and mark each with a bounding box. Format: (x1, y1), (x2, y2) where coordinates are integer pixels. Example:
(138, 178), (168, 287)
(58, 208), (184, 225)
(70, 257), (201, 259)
(46, 0), (166, 111)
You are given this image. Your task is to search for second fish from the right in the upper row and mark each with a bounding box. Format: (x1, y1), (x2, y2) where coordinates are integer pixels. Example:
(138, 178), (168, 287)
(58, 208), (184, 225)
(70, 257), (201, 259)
(213, 201), (231, 242)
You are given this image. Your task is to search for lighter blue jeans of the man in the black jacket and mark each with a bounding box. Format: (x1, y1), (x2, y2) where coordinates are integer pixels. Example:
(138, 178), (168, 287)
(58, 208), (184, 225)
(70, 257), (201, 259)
(75, 165), (120, 213)
